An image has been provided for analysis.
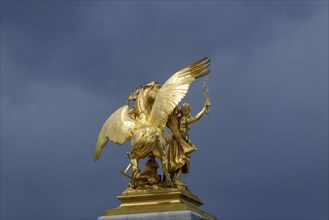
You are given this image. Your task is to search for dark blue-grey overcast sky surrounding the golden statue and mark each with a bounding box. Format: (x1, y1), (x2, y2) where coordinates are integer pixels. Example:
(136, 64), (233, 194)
(1, 0), (328, 220)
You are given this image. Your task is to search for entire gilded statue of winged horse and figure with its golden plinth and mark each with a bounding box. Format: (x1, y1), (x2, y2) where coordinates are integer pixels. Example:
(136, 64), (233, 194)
(94, 58), (213, 219)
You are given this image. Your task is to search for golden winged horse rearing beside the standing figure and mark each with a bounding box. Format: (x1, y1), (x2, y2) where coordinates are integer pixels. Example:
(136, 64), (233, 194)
(94, 58), (210, 188)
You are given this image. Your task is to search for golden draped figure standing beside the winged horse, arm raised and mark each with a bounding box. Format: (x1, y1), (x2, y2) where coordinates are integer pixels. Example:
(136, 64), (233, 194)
(168, 98), (211, 188)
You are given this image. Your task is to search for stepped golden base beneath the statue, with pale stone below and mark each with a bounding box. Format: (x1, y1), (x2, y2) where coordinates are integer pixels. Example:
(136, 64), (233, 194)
(98, 187), (216, 220)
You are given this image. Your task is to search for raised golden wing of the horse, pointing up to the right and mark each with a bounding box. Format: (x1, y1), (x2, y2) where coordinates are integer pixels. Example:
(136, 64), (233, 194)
(148, 57), (210, 128)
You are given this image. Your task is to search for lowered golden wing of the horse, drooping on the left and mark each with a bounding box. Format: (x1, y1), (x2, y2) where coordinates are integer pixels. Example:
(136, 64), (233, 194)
(94, 105), (135, 162)
